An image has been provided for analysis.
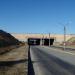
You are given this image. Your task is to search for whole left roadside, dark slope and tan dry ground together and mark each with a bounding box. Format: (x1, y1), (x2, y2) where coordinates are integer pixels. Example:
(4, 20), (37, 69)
(0, 30), (28, 75)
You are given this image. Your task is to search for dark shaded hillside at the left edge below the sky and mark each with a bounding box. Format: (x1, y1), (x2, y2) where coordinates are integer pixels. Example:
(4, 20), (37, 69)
(0, 30), (20, 47)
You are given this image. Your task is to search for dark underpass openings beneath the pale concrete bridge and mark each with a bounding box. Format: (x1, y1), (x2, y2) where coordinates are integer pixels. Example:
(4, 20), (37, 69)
(28, 38), (54, 46)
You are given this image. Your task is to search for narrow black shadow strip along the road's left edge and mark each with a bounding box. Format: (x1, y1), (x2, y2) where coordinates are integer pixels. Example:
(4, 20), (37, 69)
(28, 46), (35, 75)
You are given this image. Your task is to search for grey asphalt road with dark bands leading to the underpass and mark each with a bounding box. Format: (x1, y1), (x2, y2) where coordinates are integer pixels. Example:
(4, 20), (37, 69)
(30, 46), (75, 75)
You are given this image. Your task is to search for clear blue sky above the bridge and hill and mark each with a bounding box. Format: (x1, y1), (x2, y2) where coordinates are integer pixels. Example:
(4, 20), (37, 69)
(0, 0), (75, 34)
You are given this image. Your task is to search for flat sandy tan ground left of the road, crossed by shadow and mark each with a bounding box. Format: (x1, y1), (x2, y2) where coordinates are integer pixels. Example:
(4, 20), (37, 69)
(0, 46), (28, 75)
